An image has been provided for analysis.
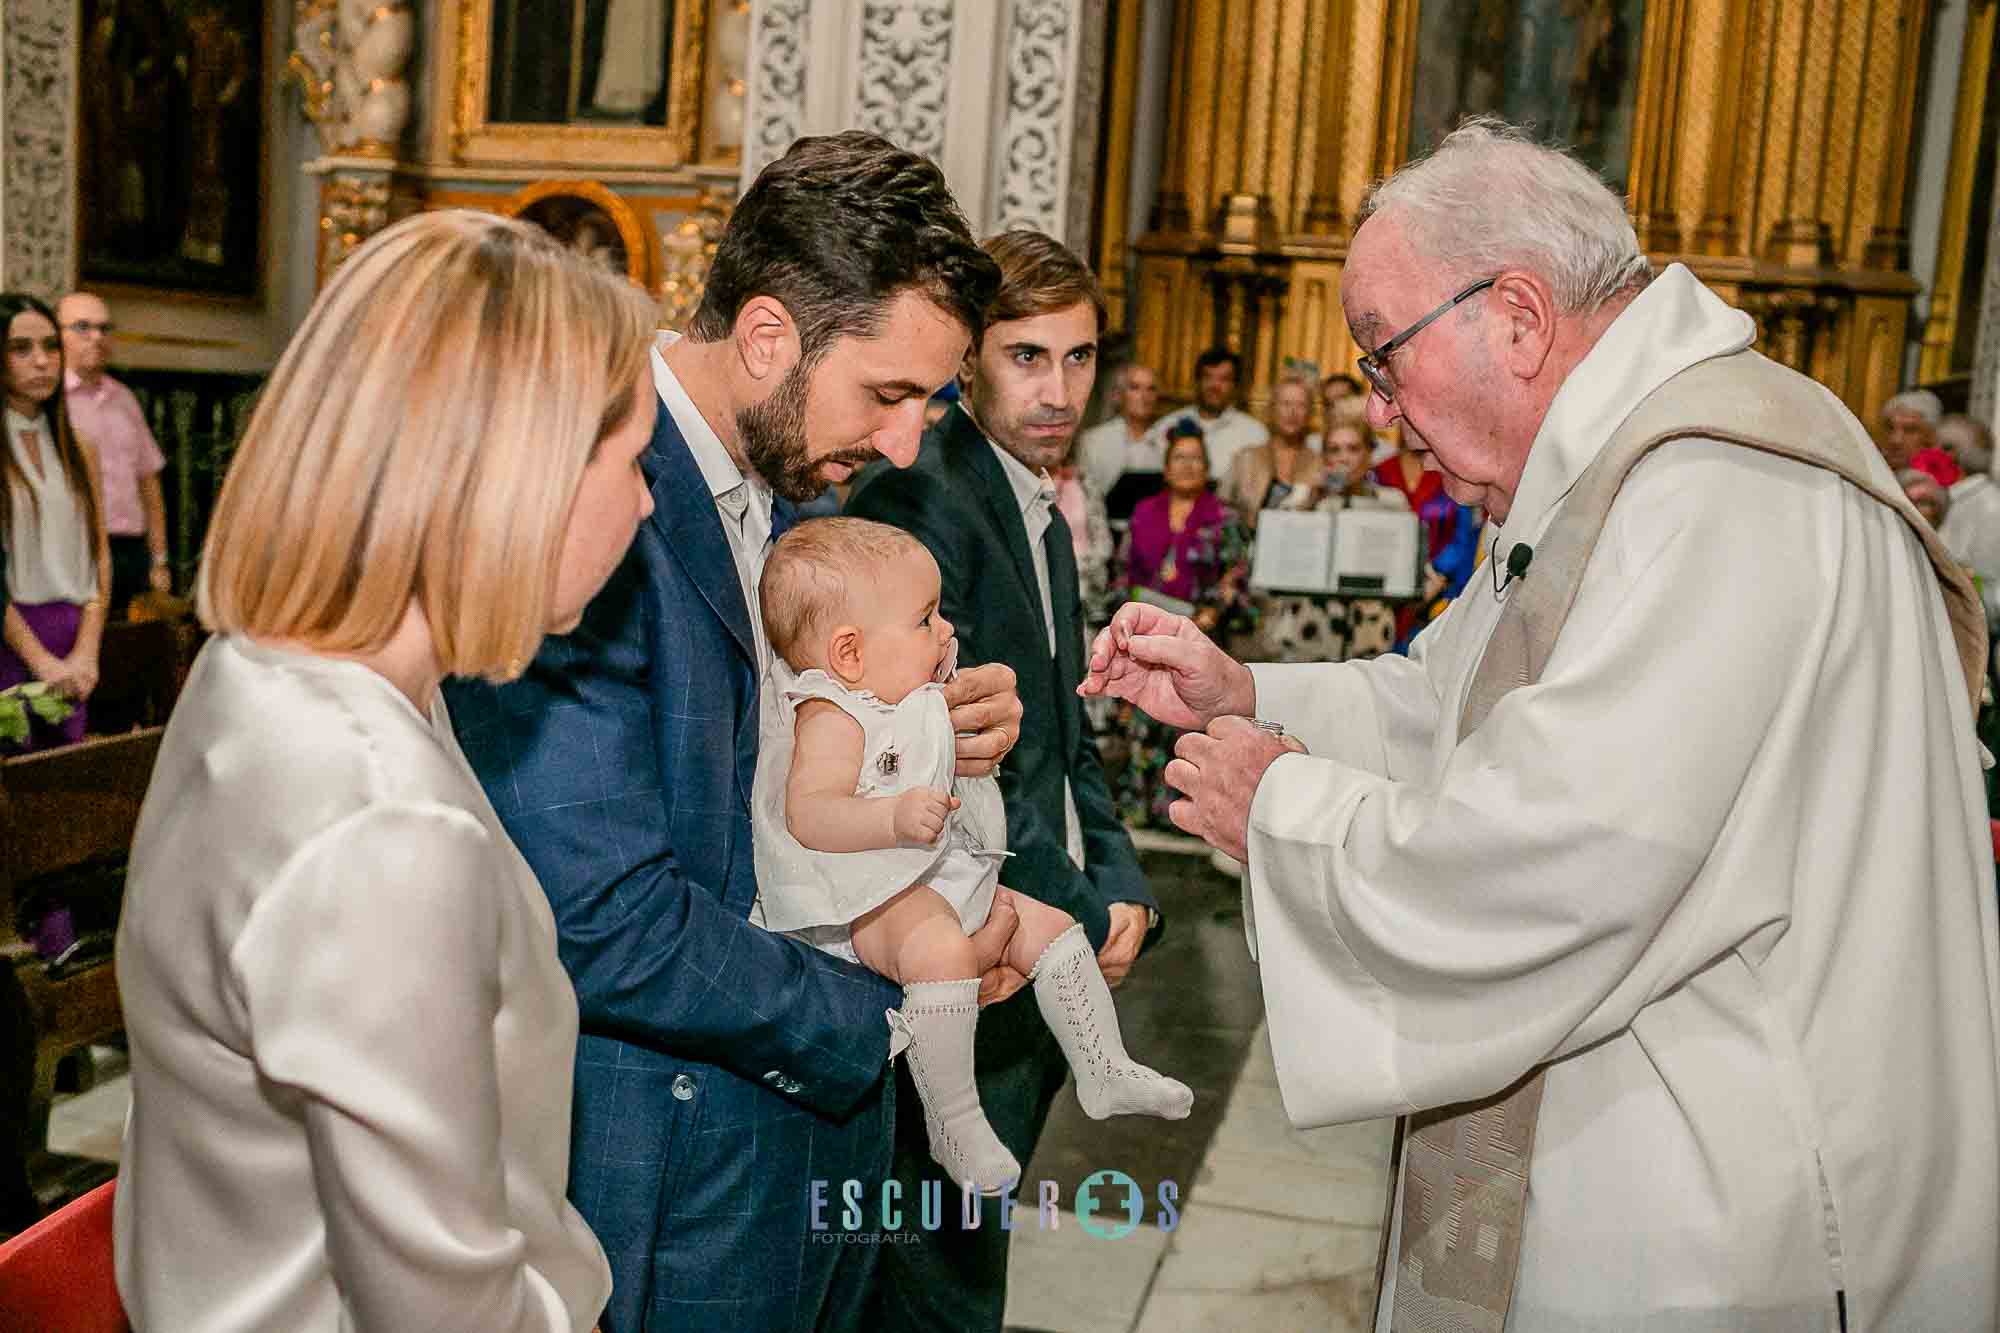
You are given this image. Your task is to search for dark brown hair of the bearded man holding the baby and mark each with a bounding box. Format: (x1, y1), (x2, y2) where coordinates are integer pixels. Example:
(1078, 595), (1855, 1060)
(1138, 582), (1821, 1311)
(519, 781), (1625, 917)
(688, 130), (1000, 364)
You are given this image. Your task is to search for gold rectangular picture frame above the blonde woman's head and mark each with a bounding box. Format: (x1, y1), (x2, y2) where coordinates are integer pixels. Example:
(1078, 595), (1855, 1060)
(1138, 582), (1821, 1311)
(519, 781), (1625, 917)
(452, 0), (708, 170)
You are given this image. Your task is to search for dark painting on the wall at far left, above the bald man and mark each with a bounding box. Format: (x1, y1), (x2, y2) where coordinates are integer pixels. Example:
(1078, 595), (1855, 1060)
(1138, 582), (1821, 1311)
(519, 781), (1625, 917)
(76, 0), (268, 298)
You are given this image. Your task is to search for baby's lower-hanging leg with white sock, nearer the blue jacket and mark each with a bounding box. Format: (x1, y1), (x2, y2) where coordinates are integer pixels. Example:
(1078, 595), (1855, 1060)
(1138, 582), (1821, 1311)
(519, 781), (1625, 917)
(852, 885), (1020, 1195)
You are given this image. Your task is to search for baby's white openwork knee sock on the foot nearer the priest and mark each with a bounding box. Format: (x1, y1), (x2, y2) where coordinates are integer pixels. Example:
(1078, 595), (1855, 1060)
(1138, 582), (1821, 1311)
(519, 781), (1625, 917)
(1034, 925), (1194, 1121)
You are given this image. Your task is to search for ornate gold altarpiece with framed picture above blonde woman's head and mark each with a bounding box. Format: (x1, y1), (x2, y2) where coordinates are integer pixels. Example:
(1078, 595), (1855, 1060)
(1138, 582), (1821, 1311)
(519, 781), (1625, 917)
(292, 0), (750, 326)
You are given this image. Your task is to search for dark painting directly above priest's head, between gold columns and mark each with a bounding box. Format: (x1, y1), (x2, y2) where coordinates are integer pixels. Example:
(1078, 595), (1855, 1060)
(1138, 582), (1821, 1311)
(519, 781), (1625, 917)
(1410, 0), (1646, 190)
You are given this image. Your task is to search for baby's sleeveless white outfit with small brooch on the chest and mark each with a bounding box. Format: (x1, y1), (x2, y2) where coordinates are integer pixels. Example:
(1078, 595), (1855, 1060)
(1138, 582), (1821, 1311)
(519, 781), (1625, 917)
(750, 660), (1006, 963)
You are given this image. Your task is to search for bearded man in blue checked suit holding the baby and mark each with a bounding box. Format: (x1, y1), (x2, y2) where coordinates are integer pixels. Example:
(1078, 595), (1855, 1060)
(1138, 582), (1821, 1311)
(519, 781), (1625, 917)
(448, 134), (1022, 1333)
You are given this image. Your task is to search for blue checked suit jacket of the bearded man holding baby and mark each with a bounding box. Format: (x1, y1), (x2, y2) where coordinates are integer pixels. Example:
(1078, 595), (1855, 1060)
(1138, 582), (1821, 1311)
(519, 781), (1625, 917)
(448, 394), (902, 1333)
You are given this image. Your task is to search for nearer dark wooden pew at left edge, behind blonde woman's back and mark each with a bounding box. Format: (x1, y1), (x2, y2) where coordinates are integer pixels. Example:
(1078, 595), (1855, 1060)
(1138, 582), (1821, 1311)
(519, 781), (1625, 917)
(0, 727), (164, 1233)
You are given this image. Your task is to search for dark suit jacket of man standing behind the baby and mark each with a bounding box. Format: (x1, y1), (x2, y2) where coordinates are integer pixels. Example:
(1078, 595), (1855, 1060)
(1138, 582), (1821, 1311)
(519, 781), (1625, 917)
(846, 406), (1156, 947)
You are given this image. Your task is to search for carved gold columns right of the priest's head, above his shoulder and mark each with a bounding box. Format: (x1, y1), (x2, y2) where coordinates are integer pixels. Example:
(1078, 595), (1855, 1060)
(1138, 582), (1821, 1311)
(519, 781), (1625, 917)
(1632, 0), (1928, 420)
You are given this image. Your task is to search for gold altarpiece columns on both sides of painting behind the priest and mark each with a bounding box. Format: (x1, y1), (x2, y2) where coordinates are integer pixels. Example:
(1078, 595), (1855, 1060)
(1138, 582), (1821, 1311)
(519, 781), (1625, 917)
(1128, 0), (1952, 420)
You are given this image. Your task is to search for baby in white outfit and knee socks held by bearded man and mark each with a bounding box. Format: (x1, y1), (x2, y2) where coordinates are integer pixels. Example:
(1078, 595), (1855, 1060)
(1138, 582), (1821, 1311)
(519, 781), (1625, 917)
(752, 518), (1194, 1193)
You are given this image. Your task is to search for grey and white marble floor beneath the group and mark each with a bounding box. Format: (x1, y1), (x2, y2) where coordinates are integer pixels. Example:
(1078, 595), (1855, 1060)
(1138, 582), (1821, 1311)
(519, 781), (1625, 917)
(48, 835), (1390, 1333)
